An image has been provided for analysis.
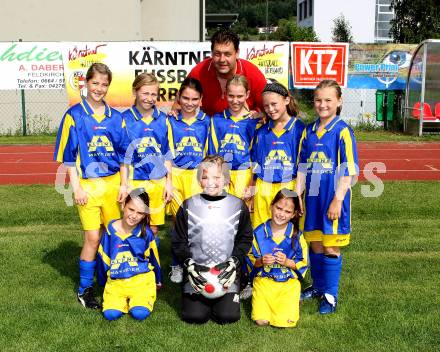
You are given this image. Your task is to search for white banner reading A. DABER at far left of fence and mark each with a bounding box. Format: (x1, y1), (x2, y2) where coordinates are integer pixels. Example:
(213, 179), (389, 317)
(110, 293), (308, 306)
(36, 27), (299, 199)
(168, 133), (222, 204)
(0, 42), (64, 90)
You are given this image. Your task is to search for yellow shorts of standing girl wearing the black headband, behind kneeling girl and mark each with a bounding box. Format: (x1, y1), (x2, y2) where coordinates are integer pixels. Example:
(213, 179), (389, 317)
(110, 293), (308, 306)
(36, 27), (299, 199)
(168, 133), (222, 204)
(252, 178), (296, 228)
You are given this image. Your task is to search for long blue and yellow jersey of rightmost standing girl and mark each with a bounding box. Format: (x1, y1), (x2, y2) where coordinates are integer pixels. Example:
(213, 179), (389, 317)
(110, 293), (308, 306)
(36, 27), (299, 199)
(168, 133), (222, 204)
(298, 116), (358, 234)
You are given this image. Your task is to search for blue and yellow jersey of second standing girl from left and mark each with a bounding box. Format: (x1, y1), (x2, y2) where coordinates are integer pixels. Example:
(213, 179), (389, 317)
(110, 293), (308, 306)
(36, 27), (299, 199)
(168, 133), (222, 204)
(122, 106), (171, 180)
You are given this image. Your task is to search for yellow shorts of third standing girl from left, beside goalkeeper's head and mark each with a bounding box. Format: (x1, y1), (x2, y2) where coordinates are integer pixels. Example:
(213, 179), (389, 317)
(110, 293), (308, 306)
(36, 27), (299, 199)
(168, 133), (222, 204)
(167, 167), (202, 216)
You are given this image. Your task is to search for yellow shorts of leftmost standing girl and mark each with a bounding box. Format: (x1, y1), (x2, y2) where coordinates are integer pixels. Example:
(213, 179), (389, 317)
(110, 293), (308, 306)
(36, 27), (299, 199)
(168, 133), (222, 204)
(78, 172), (121, 231)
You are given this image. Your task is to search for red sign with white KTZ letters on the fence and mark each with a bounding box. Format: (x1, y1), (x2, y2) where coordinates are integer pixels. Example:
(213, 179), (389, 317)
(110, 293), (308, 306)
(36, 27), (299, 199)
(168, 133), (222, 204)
(292, 43), (348, 88)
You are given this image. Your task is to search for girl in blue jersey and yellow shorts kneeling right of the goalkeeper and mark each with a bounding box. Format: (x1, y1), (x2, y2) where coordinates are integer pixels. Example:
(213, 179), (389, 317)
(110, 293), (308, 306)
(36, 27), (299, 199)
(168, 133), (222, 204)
(249, 188), (307, 327)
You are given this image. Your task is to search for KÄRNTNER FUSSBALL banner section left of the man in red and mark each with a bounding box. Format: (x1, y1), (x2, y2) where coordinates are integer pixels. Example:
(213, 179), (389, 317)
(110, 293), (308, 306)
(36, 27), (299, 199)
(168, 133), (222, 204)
(62, 42), (211, 107)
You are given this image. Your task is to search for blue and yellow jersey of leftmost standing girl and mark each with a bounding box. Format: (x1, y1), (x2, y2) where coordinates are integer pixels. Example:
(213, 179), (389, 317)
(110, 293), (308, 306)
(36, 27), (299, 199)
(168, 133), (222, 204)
(54, 99), (127, 179)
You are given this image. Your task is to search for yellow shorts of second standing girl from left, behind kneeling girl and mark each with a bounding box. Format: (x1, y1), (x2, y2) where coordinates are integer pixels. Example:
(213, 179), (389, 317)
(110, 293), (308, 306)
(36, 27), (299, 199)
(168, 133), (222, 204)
(130, 177), (166, 226)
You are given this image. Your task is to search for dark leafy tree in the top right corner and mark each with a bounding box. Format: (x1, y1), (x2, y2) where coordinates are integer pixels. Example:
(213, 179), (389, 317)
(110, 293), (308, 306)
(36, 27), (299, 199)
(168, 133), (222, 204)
(390, 0), (440, 43)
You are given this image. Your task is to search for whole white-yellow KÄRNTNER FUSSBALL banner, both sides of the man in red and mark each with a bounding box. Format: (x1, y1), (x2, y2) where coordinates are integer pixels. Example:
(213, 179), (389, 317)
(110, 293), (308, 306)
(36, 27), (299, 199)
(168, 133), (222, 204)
(62, 42), (289, 107)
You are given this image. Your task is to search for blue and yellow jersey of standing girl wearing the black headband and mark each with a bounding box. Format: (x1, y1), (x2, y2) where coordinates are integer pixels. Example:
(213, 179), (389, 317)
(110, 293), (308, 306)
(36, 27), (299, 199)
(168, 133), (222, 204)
(251, 117), (305, 183)
